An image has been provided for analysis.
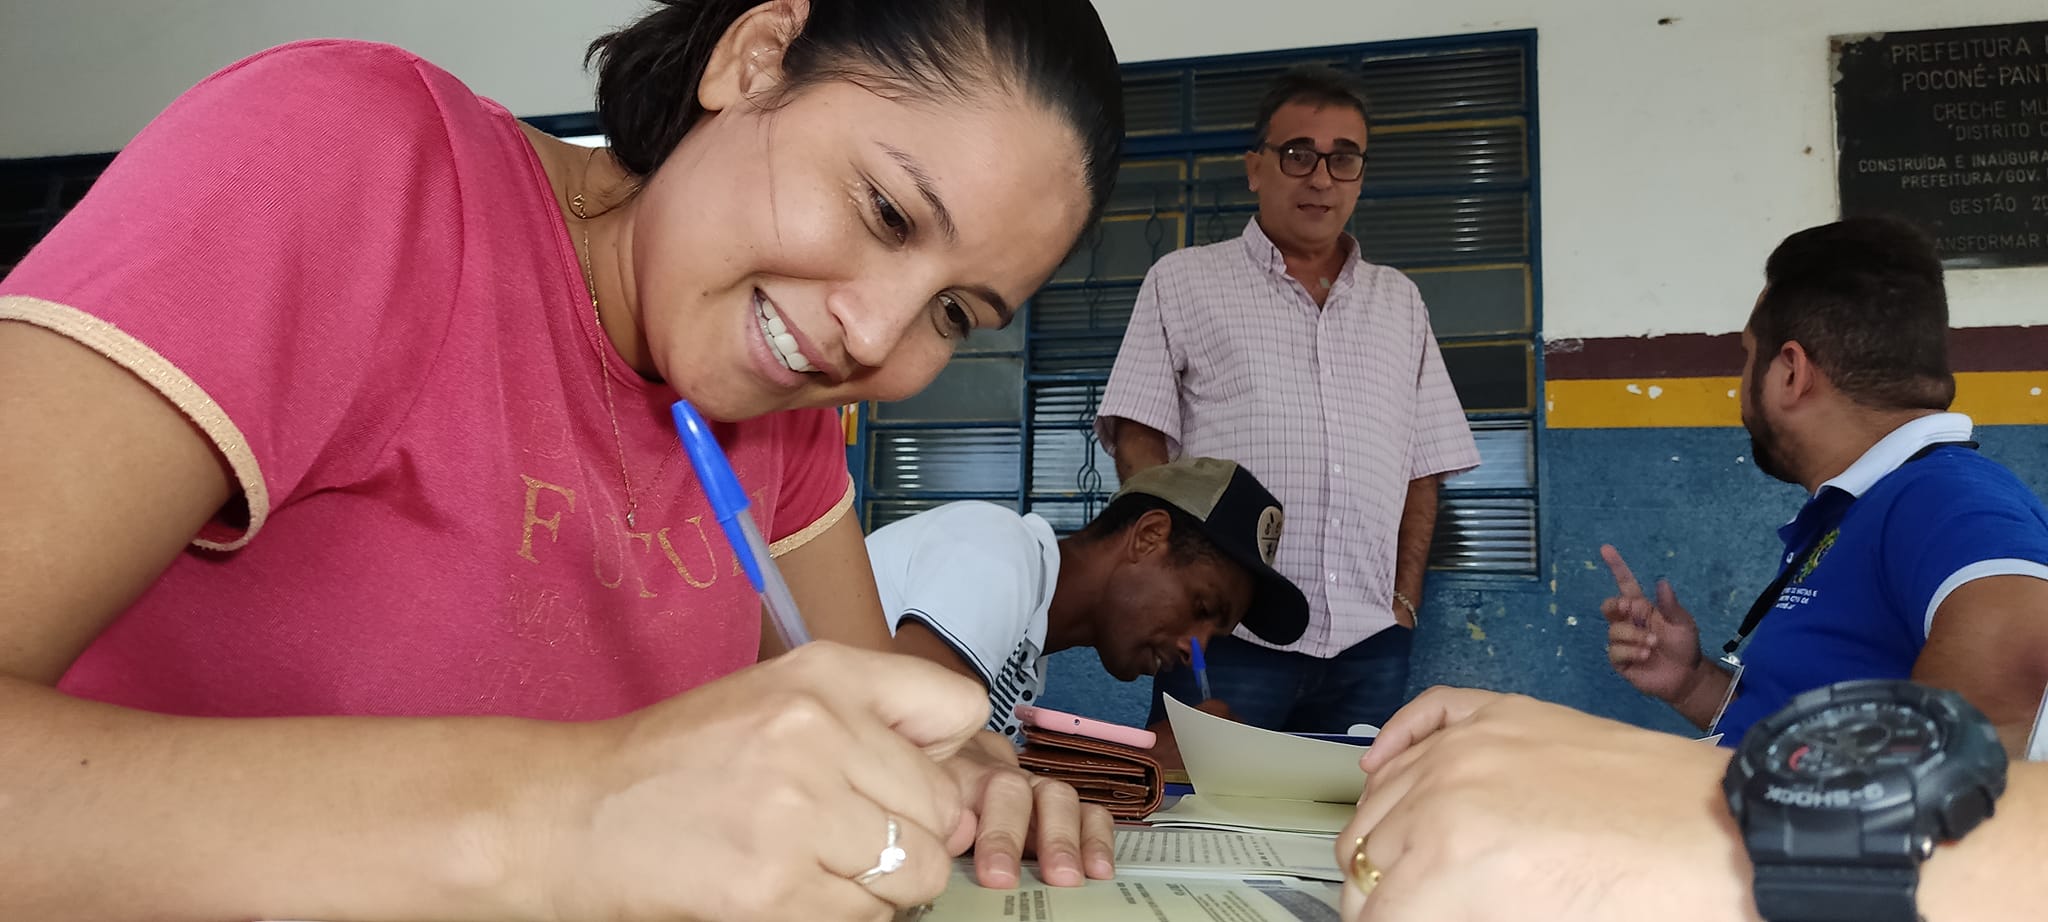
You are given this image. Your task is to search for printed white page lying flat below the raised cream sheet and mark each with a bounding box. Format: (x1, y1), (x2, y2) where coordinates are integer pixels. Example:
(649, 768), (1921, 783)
(1116, 828), (1343, 881)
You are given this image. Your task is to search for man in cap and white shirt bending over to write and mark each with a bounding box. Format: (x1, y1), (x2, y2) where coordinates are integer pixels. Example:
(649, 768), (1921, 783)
(868, 457), (1309, 744)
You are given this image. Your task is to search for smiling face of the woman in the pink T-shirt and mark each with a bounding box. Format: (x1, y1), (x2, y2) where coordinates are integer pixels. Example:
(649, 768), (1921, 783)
(627, 37), (1090, 420)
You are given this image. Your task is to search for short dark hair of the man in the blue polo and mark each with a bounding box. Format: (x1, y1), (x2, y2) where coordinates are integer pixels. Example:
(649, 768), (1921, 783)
(1749, 217), (1956, 410)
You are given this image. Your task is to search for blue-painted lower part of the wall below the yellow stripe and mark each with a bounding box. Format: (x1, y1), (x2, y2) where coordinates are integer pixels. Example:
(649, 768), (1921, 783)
(1044, 426), (2048, 731)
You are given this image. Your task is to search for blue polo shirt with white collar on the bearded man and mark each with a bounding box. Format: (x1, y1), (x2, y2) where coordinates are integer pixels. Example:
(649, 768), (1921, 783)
(1714, 414), (2048, 746)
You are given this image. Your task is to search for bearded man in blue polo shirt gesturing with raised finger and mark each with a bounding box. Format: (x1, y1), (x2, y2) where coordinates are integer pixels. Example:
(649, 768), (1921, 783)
(1602, 217), (2048, 746)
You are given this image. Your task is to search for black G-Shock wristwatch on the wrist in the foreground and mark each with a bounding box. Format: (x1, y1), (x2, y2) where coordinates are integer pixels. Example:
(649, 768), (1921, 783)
(1720, 680), (2005, 922)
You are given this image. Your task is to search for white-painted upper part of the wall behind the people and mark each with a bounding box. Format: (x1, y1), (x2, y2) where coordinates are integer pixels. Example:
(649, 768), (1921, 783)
(0, 0), (2048, 338)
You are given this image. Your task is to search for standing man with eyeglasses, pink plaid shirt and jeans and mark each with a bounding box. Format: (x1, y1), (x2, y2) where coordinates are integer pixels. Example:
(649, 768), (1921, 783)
(1096, 68), (1479, 758)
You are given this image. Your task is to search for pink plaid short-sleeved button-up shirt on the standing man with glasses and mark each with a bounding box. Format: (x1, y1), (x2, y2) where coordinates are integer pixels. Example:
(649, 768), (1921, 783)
(1096, 219), (1479, 658)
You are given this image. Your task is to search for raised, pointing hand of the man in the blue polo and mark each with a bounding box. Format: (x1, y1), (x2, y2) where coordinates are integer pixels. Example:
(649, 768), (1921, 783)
(1599, 545), (1704, 703)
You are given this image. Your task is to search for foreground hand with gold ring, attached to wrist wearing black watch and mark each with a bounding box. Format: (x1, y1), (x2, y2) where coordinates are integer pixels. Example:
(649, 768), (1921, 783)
(1335, 688), (1755, 922)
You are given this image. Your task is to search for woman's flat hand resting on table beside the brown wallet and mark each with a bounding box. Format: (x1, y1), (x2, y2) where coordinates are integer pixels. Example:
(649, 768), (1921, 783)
(944, 731), (1116, 889)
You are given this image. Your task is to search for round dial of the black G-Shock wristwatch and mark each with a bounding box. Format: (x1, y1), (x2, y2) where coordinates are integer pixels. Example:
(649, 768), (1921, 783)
(1763, 701), (1944, 783)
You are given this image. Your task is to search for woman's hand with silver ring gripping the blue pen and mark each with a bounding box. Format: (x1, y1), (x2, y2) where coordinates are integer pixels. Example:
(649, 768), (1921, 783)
(532, 641), (987, 920)
